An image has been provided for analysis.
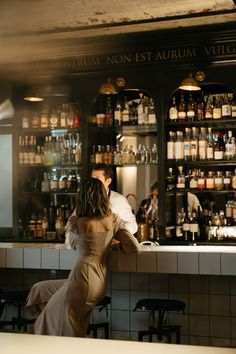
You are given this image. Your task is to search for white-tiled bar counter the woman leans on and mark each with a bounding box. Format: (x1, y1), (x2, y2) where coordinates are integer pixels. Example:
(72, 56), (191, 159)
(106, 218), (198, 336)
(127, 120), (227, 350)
(0, 243), (236, 275)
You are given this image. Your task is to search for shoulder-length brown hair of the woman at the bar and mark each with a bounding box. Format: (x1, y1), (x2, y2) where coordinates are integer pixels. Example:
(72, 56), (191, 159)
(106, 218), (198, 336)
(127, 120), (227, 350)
(76, 177), (110, 217)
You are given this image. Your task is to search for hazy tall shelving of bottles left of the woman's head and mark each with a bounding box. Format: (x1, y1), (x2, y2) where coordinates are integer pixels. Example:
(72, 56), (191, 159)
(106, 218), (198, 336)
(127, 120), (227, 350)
(18, 103), (82, 242)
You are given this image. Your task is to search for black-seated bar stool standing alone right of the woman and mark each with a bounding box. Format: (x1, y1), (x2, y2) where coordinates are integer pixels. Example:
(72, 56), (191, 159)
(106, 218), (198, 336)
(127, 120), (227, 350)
(134, 299), (186, 344)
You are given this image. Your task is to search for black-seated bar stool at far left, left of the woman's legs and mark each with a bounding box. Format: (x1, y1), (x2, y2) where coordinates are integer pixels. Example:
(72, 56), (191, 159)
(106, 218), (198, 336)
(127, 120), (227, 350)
(0, 289), (35, 332)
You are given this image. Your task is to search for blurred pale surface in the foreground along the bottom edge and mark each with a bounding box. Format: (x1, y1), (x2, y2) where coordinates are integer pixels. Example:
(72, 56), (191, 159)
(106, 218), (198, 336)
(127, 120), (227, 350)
(0, 333), (236, 354)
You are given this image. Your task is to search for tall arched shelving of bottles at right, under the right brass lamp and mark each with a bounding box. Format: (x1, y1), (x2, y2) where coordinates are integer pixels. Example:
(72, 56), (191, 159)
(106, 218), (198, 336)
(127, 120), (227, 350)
(165, 87), (236, 242)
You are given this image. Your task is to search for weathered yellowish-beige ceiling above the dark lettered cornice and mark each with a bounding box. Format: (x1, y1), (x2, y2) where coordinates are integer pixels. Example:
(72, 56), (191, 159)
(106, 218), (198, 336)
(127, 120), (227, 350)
(0, 0), (236, 65)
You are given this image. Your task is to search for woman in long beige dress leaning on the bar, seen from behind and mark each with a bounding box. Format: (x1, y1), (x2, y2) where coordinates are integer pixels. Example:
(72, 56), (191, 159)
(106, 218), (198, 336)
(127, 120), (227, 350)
(35, 178), (139, 337)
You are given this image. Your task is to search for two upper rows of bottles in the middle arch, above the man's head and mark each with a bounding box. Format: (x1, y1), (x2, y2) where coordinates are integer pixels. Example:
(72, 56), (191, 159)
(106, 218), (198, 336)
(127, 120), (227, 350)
(90, 90), (158, 166)
